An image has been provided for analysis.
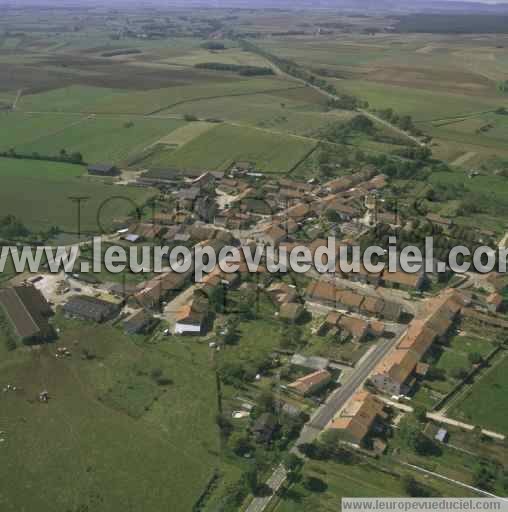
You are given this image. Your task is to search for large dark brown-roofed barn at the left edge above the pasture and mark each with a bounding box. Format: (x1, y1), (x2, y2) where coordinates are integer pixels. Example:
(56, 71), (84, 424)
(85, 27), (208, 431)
(0, 285), (55, 342)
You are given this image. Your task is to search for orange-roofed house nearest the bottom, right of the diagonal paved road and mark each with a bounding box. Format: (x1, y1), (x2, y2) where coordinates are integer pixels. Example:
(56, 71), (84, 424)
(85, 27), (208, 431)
(328, 391), (383, 446)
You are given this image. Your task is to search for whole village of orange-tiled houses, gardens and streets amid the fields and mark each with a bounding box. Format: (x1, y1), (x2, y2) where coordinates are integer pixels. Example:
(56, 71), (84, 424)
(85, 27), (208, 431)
(0, 162), (508, 500)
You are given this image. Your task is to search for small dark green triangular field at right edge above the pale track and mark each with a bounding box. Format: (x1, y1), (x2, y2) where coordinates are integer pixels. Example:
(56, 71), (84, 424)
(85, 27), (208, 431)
(449, 354), (508, 434)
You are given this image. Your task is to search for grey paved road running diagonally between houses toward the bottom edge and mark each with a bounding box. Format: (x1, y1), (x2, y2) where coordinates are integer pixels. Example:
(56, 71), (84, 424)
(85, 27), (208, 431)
(246, 329), (407, 512)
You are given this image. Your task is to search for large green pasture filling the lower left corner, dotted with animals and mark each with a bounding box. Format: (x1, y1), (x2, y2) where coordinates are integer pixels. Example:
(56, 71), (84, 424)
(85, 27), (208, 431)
(0, 318), (219, 512)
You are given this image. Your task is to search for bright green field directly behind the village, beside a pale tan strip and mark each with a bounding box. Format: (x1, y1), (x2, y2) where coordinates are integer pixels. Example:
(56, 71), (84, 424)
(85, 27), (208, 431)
(143, 124), (316, 173)
